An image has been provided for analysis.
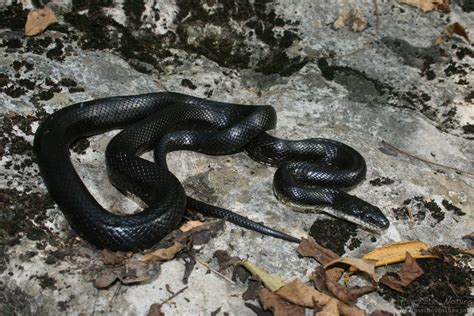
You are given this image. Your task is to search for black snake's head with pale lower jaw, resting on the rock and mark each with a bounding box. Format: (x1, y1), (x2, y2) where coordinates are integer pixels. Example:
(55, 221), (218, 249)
(334, 192), (390, 232)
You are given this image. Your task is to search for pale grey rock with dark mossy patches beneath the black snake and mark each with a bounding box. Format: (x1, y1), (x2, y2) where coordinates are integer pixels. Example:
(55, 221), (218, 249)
(0, 0), (474, 315)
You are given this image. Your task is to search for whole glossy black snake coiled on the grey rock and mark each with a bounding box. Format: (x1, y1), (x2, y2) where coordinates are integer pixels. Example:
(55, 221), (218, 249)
(34, 92), (389, 250)
